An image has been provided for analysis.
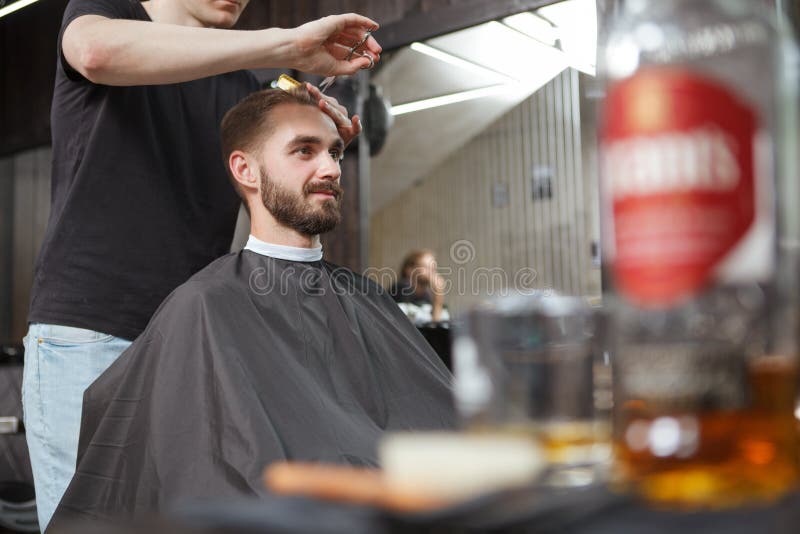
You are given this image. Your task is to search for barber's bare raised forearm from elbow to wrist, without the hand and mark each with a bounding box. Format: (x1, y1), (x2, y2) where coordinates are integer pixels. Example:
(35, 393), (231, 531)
(62, 16), (293, 85)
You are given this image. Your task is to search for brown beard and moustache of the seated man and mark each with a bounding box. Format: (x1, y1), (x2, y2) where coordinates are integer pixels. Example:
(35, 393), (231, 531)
(261, 168), (344, 236)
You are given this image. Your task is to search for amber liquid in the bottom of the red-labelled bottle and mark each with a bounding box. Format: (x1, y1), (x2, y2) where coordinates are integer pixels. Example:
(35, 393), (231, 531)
(614, 356), (798, 508)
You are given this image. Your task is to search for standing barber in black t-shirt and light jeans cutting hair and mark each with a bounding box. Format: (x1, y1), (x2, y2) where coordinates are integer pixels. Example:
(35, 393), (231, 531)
(23, 0), (381, 530)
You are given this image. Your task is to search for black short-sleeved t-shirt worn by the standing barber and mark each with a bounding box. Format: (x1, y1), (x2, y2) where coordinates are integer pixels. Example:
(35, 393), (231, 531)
(28, 0), (258, 339)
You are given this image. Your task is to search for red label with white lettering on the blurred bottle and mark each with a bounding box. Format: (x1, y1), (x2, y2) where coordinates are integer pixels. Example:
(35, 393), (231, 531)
(601, 69), (758, 307)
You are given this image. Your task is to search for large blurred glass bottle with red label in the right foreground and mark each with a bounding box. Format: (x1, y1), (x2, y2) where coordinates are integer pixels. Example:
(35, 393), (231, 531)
(600, 0), (800, 507)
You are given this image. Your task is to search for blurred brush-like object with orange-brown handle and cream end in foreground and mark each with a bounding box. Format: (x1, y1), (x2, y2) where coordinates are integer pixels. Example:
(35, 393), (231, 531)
(264, 432), (545, 511)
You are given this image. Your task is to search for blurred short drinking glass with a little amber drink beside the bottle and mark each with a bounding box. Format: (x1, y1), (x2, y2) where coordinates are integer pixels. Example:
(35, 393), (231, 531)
(453, 295), (610, 486)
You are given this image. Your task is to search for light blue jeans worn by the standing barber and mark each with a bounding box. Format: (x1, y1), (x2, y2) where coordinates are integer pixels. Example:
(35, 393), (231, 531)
(22, 324), (131, 532)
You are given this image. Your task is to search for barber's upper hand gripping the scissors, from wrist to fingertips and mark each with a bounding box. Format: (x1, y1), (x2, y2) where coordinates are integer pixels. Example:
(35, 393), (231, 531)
(289, 13), (382, 76)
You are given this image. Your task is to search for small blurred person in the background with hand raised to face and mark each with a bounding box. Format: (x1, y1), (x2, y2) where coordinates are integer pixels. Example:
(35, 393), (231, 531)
(389, 249), (450, 325)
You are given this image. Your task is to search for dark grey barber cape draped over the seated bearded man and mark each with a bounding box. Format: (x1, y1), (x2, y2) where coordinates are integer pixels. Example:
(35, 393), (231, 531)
(48, 250), (455, 530)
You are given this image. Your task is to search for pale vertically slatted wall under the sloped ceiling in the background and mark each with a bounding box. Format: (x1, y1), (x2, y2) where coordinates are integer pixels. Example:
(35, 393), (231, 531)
(370, 69), (600, 313)
